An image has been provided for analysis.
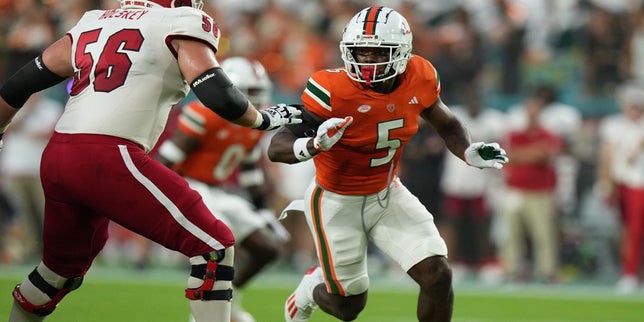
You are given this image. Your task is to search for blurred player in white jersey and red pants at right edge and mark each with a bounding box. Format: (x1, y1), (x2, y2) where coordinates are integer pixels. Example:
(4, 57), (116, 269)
(596, 81), (644, 294)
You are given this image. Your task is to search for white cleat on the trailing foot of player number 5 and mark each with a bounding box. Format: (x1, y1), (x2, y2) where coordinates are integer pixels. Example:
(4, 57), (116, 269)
(284, 266), (324, 322)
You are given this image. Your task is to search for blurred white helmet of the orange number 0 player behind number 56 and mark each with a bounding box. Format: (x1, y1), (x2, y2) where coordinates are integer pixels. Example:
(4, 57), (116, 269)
(221, 57), (273, 108)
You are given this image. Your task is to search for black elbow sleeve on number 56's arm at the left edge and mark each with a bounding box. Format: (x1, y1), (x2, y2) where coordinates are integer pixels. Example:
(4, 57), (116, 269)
(0, 55), (65, 108)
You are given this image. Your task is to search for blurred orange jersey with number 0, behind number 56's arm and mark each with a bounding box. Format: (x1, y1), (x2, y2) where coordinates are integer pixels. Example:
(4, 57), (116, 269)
(175, 101), (264, 185)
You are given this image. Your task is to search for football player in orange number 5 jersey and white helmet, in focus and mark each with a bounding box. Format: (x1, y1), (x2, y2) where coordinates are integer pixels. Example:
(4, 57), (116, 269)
(268, 6), (508, 322)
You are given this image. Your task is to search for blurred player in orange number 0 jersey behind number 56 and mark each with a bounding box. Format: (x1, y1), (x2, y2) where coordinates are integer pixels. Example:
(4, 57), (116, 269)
(157, 57), (289, 322)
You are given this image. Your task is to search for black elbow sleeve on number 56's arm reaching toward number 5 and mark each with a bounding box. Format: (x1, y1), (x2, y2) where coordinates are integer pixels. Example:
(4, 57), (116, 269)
(190, 67), (248, 121)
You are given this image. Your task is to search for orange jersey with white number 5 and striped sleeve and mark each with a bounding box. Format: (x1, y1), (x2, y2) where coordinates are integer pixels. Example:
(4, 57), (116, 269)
(302, 56), (440, 195)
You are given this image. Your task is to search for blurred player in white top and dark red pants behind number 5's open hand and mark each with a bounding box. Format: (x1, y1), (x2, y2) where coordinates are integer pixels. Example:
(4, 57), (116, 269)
(439, 87), (505, 283)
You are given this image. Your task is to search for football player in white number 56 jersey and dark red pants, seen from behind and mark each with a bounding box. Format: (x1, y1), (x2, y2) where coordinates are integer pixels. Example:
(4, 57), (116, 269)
(0, 0), (301, 322)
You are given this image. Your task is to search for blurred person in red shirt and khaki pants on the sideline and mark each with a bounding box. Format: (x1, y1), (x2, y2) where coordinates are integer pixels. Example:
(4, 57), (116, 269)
(498, 89), (563, 283)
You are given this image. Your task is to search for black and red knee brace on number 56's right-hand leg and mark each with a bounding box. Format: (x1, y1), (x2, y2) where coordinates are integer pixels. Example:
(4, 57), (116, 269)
(186, 247), (235, 301)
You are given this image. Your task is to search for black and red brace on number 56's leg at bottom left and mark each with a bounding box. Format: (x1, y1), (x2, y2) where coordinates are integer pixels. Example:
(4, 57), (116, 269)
(12, 268), (83, 316)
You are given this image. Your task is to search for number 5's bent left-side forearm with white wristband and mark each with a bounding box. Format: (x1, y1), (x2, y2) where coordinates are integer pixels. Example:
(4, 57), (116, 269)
(267, 128), (320, 164)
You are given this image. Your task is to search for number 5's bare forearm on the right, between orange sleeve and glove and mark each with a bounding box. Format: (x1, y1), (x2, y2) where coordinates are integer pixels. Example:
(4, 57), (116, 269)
(421, 97), (471, 162)
